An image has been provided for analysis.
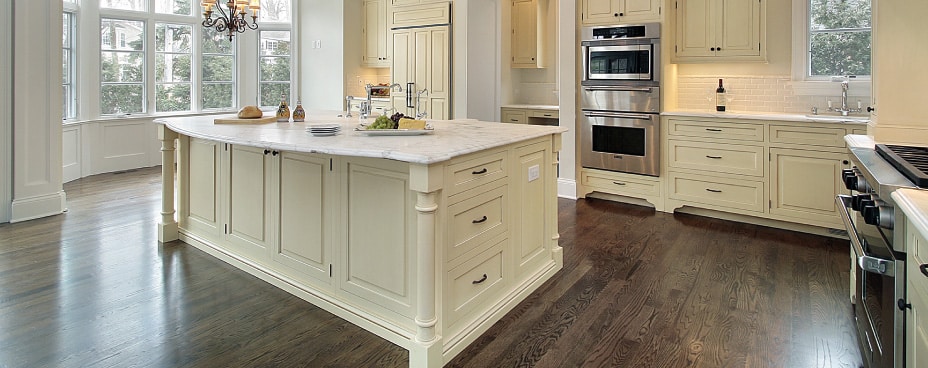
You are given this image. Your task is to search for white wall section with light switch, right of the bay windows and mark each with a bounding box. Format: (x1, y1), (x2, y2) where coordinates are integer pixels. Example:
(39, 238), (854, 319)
(294, 0), (348, 110)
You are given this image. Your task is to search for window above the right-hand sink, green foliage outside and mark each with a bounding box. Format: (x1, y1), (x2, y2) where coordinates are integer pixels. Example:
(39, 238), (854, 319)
(793, 0), (871, 80)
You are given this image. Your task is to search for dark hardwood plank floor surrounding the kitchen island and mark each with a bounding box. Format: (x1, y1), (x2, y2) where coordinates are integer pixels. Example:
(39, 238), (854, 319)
(0, 168), (861, 368)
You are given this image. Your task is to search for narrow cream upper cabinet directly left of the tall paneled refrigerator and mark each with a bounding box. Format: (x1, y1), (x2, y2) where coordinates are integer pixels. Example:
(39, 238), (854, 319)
(361, 0), (393, 68)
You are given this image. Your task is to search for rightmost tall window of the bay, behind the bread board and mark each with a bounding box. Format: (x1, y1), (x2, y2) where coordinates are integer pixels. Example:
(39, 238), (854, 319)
(258, 31), (290, 106)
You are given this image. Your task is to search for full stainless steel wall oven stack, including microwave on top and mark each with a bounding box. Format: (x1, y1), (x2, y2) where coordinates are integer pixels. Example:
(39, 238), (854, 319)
(580, 23), (661, 176)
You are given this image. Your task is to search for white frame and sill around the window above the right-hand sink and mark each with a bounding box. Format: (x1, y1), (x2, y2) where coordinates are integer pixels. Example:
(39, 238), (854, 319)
(791, 0), (873, 96)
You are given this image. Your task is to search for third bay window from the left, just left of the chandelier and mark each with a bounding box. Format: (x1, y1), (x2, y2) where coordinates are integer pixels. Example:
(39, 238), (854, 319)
(155, 23), (193, 112)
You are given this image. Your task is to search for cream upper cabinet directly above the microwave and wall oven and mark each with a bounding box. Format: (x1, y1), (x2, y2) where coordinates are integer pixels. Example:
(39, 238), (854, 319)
(582, 0), (661, 26)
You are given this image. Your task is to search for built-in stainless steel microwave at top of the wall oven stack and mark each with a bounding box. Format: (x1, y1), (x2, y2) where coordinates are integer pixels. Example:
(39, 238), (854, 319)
(580, 23), (661, 86)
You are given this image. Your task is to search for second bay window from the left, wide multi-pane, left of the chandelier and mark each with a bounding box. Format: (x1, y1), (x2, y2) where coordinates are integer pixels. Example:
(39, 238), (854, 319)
(100, 17), (145, 115)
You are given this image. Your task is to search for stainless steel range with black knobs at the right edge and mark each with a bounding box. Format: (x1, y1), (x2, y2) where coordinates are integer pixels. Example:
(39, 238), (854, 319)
(836, 136), (928, 368)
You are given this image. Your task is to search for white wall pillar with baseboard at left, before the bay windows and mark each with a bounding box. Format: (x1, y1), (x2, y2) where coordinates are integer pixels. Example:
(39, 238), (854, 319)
(11, 0), (65, 222)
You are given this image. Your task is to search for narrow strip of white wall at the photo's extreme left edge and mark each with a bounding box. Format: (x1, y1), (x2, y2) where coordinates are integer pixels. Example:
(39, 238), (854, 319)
(0, 0), (13, 223)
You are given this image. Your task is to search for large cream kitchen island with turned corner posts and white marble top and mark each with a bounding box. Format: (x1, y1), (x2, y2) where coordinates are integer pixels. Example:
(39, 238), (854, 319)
(156, 113), (565, 367)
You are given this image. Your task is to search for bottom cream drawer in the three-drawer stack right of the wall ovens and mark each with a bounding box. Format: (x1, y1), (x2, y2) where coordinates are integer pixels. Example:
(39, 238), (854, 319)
(668, 173), (764, 212)
